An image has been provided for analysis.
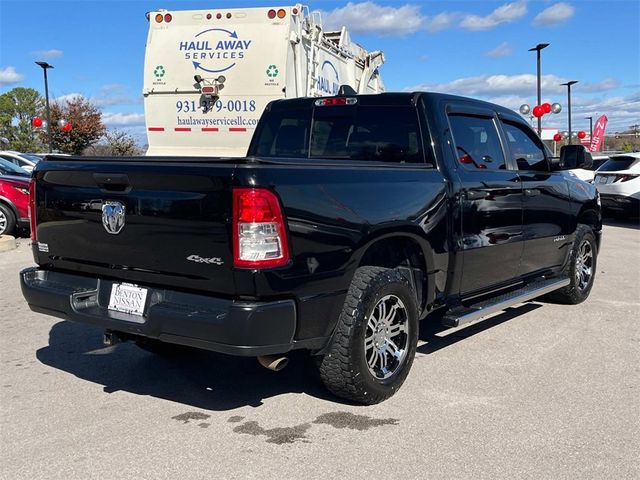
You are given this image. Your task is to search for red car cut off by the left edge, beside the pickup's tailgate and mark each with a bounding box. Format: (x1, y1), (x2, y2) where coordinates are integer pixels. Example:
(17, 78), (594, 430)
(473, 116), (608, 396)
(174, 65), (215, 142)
(0, 175), (29, 235)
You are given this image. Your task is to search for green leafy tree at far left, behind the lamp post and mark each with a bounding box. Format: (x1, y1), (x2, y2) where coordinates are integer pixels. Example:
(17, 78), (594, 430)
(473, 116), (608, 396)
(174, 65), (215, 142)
(0, 87), (44, 152)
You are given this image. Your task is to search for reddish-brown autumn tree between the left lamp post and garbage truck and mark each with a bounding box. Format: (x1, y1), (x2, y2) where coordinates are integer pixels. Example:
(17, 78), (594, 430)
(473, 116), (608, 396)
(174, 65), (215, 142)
(40, 96), (106, 155)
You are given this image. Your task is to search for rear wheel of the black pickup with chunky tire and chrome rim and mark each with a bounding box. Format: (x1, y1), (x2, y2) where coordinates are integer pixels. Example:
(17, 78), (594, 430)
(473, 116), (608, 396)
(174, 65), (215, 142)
(319, 267), (418, 405)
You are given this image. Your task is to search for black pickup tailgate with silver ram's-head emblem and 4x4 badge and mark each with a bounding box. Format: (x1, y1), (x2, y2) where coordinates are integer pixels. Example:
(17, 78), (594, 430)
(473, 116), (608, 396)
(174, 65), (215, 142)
(34, 157), (236, 295)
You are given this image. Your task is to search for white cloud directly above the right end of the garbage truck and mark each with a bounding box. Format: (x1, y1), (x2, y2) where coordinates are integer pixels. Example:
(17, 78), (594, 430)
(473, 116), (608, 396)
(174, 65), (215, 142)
(322, 1), (425, 36)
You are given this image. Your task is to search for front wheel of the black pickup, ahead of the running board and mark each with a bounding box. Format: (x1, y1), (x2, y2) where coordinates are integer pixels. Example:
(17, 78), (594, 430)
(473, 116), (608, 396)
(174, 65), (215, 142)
(547, 224), (598, 305)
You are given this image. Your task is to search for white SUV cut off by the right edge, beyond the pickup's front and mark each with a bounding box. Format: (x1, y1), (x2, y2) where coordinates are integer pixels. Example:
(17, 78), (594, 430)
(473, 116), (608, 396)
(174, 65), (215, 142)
(593, 152), (640, 216)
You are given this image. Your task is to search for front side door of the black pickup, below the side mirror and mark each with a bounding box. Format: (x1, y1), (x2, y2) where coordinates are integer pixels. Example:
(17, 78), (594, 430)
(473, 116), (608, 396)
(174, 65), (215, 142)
(501, 116), (571, 275)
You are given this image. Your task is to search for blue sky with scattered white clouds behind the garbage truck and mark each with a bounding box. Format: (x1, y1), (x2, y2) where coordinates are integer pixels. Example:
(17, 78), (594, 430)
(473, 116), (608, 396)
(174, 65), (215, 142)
(0, 0), (640, 144)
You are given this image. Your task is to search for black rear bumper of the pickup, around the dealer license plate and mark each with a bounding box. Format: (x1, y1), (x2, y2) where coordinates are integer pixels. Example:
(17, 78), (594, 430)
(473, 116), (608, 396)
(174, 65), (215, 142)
(20, 267), (300, 356)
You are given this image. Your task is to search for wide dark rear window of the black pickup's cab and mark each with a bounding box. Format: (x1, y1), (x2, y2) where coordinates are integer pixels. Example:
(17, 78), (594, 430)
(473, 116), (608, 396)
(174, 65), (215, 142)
(253, 104), (424, 163)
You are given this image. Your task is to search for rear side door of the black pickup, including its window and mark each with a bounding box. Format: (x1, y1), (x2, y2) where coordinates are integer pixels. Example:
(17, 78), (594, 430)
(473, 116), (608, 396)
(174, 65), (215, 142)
(448, 105), (522, 296)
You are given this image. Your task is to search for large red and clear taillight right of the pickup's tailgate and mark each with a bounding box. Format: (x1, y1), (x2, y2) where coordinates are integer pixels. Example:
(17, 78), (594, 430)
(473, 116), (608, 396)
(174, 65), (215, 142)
(233, 188), (289, 268)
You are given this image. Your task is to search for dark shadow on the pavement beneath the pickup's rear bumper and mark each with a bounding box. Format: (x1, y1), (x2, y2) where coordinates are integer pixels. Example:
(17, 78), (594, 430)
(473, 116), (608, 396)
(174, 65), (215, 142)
(36, 322), (341, 411)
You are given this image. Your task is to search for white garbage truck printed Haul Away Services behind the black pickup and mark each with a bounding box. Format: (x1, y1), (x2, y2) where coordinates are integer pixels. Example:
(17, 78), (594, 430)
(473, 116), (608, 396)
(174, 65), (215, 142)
(143, 4), (384, 157)
